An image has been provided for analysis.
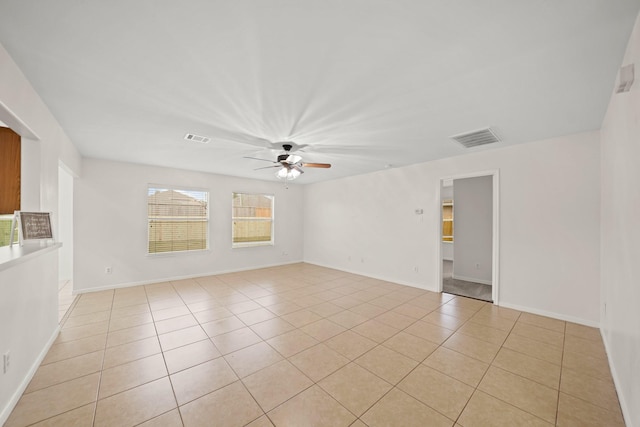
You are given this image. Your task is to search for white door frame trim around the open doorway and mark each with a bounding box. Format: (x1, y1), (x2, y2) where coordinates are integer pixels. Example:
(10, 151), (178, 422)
(435, 169), (500, 305)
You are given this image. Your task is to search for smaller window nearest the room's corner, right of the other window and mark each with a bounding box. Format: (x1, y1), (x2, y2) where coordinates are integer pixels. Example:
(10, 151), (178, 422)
(231, 193), (274, 248)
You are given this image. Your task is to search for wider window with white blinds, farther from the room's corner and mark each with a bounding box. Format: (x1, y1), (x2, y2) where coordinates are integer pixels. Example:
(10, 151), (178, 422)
(147, 185), (209, 254)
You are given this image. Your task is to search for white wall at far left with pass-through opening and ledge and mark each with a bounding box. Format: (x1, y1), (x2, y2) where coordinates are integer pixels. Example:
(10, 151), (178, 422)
(0, 45), (81, 424)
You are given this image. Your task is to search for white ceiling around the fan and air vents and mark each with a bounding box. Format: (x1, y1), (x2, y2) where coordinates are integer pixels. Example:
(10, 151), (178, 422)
(0, 0), (640, 183)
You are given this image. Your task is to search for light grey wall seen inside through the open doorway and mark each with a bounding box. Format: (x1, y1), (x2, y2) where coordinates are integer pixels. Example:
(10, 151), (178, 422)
(453, 176), (493, 285)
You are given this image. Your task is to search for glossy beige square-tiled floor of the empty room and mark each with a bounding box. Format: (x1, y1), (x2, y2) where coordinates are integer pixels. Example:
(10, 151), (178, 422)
(6, 264), (624, 427)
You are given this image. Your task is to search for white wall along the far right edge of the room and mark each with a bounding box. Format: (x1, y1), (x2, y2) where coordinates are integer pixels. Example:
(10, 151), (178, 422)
(601, 13), (640, 426)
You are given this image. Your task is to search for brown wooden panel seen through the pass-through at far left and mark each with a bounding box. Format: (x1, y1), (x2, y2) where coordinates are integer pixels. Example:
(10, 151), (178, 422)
(0, 127), (20, 214)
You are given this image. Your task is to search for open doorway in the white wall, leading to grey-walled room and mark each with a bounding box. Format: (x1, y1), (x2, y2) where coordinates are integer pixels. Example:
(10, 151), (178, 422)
(437, 171), (499, 304)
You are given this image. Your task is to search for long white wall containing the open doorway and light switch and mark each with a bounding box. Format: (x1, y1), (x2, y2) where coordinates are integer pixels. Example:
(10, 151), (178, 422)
(304, 132), (600, 325)
